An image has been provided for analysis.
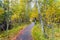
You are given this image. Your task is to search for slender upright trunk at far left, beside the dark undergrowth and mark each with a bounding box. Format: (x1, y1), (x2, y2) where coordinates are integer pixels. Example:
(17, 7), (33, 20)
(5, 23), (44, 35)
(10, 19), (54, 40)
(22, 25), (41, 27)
(4, 0), (9, 39)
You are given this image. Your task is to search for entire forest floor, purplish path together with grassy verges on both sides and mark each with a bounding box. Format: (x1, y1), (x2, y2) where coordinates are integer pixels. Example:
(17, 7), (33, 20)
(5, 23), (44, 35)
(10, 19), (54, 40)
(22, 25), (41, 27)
(0, 22), (60, 40)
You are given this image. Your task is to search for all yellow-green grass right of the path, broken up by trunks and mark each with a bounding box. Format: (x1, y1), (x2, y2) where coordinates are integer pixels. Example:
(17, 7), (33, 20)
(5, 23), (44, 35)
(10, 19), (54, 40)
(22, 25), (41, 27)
(32, 23), (60, 40)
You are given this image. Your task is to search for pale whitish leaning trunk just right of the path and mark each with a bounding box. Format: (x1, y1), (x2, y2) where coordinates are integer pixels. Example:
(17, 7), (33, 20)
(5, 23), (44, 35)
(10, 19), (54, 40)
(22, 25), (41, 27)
(35, 0), (45, 33)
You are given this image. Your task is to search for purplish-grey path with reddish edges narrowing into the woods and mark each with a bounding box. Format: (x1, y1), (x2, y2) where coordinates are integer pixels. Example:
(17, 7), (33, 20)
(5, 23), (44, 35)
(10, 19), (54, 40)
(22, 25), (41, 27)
(16, 22), (34, 40)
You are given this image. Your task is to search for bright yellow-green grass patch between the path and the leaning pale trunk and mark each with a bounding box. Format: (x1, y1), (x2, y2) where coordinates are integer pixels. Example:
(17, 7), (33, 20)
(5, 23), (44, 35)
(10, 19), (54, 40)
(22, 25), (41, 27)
(32, 24), (45, 40)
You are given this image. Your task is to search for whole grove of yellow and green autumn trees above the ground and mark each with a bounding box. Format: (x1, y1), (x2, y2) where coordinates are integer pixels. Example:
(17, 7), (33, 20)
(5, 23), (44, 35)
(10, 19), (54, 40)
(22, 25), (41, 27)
(0, 0), (60, 38)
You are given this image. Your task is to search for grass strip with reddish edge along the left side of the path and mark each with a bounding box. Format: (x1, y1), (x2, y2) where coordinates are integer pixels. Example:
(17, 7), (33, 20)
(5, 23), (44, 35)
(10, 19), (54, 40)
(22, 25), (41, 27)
(0, 24), (27, 40)
